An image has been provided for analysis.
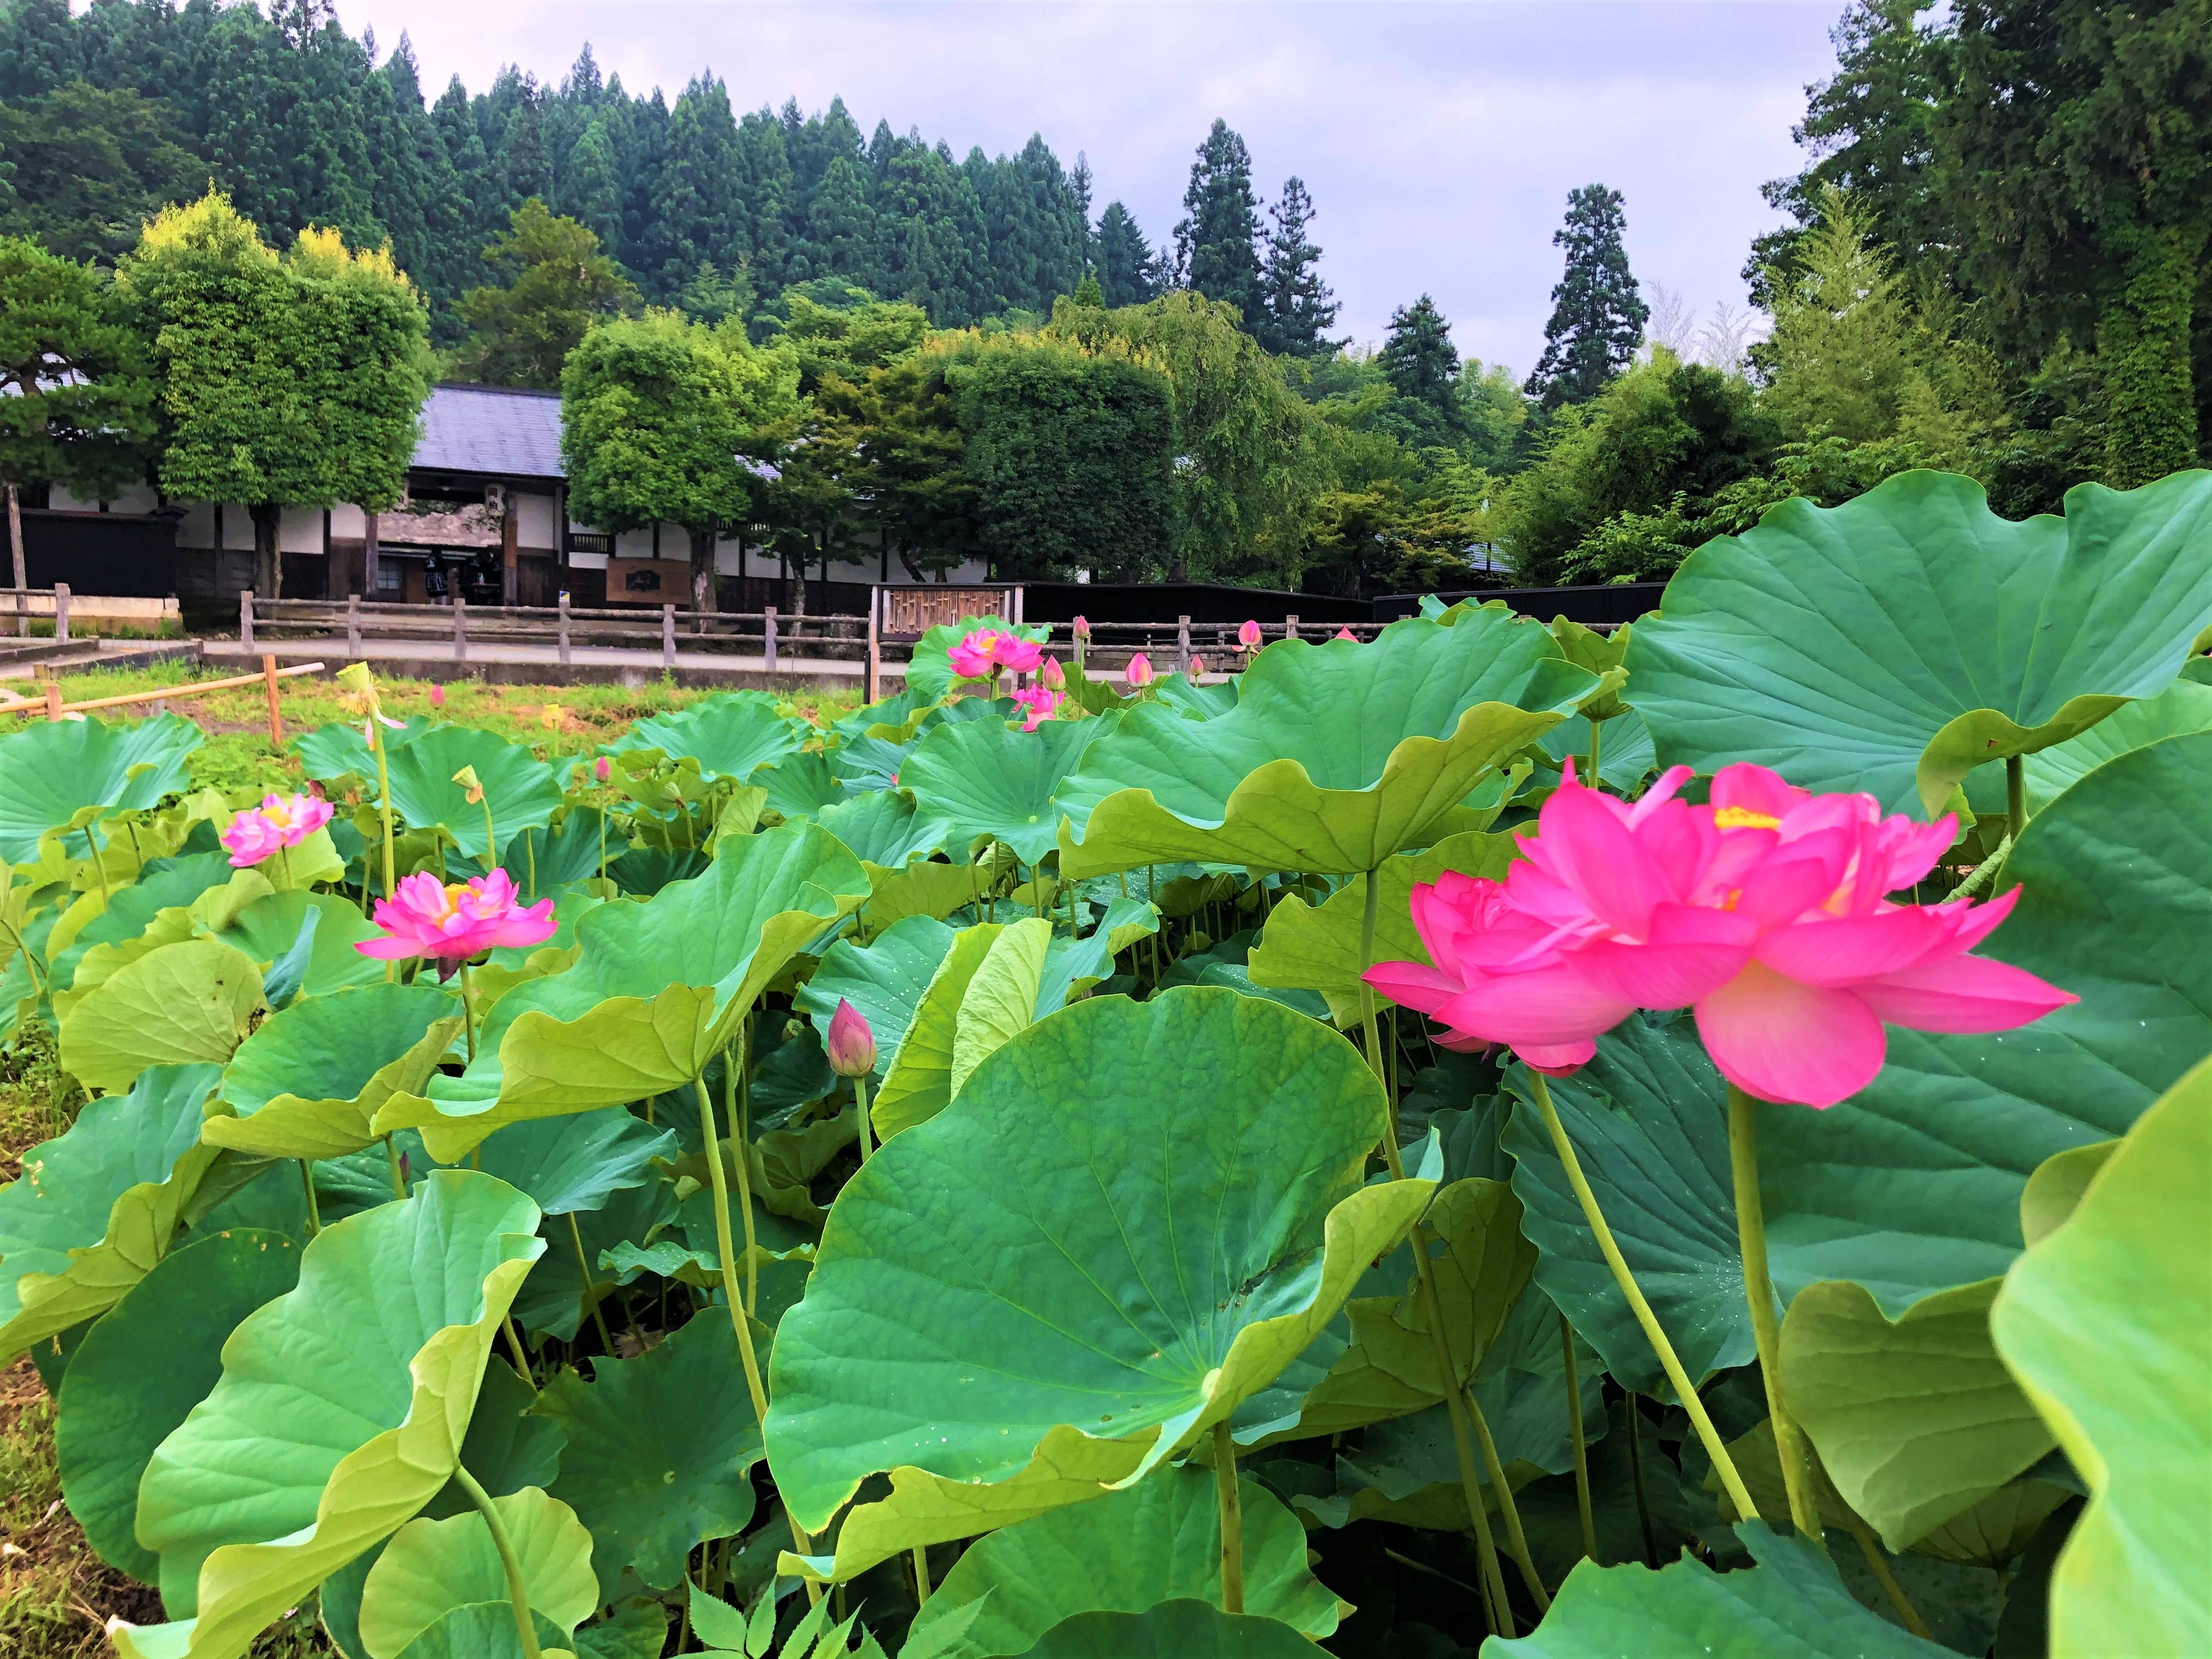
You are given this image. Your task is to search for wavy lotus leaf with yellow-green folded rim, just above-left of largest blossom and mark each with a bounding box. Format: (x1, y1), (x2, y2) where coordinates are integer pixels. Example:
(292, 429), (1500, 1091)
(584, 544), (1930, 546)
(1058, 608), (1597, 876)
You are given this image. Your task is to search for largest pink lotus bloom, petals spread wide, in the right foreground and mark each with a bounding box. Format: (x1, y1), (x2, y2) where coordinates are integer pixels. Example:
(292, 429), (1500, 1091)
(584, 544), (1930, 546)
(1367, 763), (2080, 1106)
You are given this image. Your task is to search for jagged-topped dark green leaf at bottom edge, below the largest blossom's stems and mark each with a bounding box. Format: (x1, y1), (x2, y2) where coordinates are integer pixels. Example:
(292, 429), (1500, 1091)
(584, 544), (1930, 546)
(1482, 1522), (1949, 1659)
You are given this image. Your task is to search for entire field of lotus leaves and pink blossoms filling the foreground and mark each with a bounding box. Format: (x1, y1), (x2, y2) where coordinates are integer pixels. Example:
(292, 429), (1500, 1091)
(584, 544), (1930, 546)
(0, 474), (2212, 1659)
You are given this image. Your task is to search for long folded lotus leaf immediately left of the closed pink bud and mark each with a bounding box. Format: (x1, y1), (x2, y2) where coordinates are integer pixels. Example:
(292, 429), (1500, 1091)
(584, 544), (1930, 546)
(376, 825), (867, 1164)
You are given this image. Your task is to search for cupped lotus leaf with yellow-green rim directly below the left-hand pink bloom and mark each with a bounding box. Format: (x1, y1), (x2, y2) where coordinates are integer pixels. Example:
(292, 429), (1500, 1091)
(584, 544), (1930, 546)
(206, 982), (460, 1159)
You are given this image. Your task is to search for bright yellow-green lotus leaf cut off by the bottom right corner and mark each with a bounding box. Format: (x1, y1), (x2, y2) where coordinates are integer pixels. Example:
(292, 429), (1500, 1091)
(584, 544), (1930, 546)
(1991, 1064), (2212, 1659)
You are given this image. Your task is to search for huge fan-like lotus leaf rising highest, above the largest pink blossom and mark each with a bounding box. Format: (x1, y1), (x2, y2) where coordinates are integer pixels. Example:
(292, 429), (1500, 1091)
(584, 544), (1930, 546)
(1628, 471), (2212, 819)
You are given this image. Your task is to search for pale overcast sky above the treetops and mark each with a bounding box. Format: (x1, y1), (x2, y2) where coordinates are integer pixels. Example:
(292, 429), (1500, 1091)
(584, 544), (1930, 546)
(339, 0), (1843, 374)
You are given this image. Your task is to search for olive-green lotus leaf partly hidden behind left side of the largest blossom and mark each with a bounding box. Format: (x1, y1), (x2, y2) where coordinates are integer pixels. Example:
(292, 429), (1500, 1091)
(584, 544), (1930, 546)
(1250, 834), (1520, 1027)
